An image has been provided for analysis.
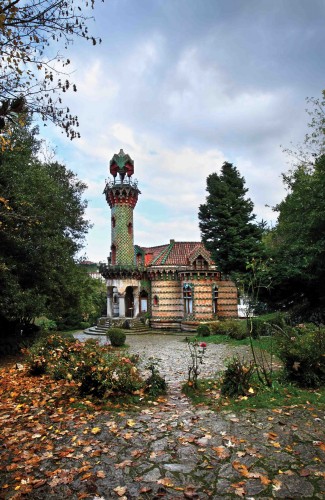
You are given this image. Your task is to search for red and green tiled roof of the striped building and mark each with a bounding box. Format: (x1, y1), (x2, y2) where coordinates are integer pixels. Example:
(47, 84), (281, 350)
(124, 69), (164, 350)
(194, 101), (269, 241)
(141, 240), (214, 266)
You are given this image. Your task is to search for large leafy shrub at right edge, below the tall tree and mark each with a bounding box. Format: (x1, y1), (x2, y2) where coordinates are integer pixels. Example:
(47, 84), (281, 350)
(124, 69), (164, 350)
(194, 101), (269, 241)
(276, 324), (325, 387)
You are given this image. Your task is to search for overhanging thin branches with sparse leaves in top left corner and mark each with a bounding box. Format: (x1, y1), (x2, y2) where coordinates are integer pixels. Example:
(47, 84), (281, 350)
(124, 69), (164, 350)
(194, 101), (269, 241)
(0, 0), (100, 139)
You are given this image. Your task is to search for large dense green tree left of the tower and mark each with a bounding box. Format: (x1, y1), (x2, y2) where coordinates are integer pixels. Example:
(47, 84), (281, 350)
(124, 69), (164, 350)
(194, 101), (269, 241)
(0, 120), (95, 332)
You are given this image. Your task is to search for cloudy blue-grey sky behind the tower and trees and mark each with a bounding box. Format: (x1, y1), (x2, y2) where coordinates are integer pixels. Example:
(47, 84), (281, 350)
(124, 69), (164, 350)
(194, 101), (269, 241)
(41, 0), (325, 261)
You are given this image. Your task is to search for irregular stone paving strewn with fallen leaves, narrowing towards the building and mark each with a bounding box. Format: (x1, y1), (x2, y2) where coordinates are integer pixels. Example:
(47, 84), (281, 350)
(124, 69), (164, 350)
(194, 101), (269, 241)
(62, 335), (325, 500)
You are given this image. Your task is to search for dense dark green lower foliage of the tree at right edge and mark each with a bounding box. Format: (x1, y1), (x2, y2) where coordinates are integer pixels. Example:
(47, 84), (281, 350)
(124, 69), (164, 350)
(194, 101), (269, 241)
(266, 156), (325, 314)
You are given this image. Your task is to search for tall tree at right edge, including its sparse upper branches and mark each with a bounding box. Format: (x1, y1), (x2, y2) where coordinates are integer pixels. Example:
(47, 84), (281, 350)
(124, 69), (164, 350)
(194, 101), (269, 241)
(265, 91), (325, 321)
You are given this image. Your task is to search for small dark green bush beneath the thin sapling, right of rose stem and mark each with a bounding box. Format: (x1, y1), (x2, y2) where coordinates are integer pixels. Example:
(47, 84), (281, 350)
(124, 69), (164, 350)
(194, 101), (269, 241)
(221, 357), (254, 397)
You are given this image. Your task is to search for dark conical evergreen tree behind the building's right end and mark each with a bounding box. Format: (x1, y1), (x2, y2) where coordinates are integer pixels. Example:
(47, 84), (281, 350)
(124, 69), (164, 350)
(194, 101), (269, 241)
(199, 162), (262, 274)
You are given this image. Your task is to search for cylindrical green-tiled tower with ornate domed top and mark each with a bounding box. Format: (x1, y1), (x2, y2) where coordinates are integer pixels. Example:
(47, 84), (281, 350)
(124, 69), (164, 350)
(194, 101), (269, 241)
(104, 149), (140, 266)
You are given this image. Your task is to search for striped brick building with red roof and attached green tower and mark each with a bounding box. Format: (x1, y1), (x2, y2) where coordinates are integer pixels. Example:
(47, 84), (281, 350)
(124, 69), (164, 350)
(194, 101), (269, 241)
(100, 149), (237, 330)
